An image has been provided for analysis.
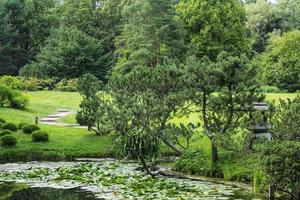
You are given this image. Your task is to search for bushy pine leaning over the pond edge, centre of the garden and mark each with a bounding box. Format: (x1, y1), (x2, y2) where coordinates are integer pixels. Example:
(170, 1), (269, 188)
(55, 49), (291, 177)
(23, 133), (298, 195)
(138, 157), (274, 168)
(108, 64), (189, 173)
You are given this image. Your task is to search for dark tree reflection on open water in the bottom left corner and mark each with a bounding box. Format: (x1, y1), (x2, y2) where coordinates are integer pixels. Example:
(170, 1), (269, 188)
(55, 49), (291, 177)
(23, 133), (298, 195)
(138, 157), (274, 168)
(0, 184), (96, 200)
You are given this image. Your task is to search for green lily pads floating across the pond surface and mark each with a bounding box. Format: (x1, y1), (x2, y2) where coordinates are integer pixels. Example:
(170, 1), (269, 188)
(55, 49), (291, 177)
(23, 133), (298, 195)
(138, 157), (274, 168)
(0, 160), (262, 199)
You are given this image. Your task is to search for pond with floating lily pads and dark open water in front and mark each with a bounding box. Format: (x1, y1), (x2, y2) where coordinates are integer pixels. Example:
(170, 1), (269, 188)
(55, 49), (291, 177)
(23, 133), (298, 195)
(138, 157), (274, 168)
(0, 160), (263, 200)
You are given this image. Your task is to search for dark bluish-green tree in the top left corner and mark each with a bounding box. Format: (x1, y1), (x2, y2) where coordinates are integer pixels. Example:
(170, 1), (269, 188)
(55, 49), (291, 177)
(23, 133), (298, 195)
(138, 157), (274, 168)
(0, 0), (57, 74)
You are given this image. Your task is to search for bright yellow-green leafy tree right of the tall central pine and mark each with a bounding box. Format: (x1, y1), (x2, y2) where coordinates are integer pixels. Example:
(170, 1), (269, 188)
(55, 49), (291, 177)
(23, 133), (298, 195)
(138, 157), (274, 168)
(177, 0), (249, 60)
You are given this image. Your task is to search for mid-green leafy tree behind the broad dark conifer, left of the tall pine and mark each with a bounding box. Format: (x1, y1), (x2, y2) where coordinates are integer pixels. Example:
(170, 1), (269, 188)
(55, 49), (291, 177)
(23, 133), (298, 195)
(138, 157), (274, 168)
(58, 0), (127, 76)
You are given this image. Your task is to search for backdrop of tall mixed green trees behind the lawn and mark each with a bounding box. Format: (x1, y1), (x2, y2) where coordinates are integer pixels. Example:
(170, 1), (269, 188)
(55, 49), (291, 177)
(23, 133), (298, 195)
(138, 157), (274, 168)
(0, 0), (300, 92)
